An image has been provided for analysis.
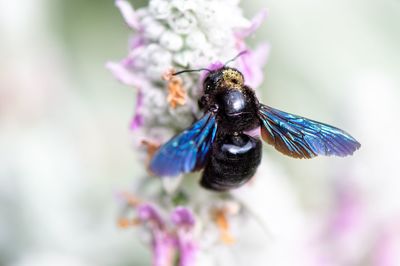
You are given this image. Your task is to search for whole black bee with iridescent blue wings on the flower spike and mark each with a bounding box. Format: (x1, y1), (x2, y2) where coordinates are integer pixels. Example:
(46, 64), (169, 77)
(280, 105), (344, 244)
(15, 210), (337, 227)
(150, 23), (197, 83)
(150, 58), (360, 191)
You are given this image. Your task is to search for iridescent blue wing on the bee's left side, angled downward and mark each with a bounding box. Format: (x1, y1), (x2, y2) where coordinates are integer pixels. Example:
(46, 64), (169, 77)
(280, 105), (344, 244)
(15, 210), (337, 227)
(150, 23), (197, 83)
(150, 113), (217, 176)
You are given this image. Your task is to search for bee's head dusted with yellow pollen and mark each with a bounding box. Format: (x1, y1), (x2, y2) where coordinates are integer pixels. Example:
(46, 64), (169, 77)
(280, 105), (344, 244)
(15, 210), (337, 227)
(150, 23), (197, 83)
(203, 67), (244, 93)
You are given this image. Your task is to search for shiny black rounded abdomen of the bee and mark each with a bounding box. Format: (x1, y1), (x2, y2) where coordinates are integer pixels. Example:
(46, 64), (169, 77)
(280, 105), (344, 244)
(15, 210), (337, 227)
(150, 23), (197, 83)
(201, 134), (261, 191)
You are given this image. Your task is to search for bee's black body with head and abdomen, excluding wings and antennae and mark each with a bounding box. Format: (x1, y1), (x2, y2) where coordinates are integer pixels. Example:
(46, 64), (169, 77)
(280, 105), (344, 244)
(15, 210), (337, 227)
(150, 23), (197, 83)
(199, 68), (262, 191)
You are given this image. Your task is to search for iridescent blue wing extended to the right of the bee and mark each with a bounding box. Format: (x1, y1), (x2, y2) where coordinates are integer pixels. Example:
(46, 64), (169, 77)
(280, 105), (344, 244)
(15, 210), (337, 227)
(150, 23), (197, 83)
(258, 104), (360, 158)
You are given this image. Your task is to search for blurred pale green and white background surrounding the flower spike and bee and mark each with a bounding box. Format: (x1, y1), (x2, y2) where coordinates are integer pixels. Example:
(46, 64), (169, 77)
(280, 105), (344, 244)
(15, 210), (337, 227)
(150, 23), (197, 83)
(0, 0), (400, 266)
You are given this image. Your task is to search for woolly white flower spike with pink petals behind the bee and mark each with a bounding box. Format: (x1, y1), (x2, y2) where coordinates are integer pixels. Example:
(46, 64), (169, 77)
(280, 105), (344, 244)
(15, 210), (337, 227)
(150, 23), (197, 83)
(106, 0), (269, 266)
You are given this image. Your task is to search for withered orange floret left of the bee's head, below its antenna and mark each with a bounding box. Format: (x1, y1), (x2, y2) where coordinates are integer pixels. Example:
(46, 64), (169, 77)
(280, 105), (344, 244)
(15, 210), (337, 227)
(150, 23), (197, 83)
(163, 69), (187, 109)
